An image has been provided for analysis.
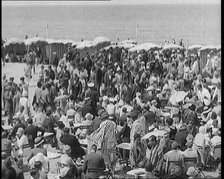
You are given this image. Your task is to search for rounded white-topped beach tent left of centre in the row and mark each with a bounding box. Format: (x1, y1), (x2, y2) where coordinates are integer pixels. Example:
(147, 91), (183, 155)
(76, 40), (97, 59)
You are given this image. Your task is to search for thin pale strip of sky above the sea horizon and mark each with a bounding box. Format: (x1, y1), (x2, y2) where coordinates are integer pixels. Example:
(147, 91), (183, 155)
(2, 0), (221, 6)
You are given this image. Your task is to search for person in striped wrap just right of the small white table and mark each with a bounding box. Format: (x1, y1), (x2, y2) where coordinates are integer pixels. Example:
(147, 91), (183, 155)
(130, 133), (146, 167)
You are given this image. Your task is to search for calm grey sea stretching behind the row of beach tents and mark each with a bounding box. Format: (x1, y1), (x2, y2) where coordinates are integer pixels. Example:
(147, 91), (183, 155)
(2, 5), (221, 45)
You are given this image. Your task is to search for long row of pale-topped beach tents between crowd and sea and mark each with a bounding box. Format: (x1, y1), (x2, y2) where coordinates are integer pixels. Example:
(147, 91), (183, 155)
(2, 37), (221, 70)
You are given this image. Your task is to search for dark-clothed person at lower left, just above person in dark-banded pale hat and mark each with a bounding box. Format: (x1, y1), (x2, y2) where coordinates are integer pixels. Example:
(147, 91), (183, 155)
(24, 118), (44, 149)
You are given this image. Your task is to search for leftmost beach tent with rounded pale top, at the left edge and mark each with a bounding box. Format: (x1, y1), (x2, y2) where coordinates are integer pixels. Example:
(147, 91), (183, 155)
(3, 38), (26, 56)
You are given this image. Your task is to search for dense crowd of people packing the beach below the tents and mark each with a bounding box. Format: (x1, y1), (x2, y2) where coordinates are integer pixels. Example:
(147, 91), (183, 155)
(2, 42), (221, 179)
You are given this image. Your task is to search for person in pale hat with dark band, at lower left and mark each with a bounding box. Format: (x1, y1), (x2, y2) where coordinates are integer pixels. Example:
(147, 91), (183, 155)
(27, 137), (47, 162)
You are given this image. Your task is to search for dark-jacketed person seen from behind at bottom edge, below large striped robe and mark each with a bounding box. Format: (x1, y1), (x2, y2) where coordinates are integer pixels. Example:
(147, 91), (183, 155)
(83, 144), (106, 179)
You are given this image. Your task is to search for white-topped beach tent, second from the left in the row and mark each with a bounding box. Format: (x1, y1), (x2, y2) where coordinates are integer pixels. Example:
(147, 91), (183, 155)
(24, 37), (47, 59)
